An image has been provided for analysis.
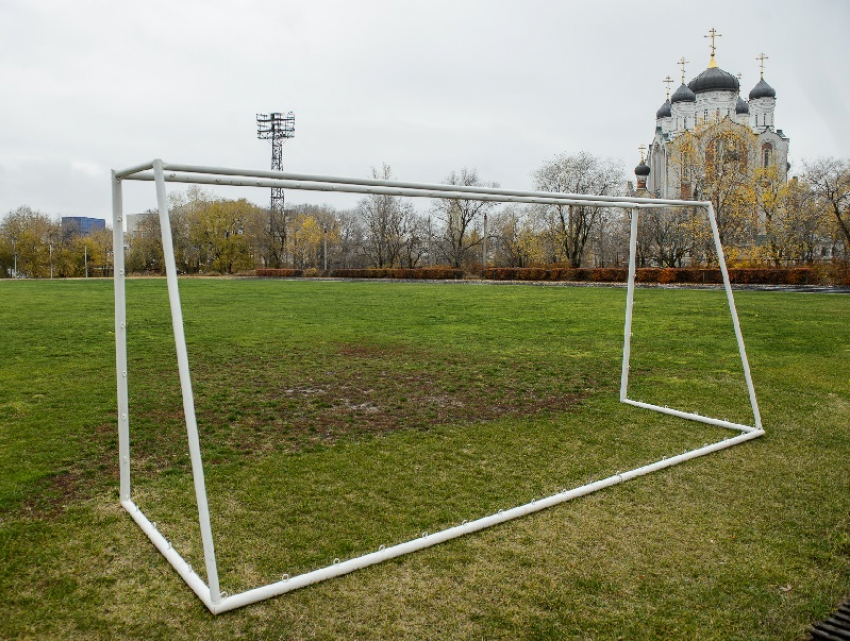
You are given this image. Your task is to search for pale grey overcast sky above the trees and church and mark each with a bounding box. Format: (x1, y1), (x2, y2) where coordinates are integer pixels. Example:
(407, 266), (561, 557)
(0, 0), (850, 218)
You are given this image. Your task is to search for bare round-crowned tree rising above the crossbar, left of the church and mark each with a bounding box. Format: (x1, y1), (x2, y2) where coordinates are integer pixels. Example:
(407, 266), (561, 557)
(534, 151), (624, 267)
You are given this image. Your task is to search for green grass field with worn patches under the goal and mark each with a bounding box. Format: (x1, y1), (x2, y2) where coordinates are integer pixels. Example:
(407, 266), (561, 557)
(0, 280), (850, 640)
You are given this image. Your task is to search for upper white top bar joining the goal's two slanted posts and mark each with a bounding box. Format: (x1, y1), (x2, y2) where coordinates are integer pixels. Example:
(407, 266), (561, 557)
(152, 163), (706, 207)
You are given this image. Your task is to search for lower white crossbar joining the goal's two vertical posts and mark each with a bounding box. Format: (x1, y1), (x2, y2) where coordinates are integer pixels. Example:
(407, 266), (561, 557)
(127, 172), (668, 208)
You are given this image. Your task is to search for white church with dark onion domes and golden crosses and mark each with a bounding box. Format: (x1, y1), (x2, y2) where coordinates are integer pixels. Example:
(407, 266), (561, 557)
(635, 29), (788, 198)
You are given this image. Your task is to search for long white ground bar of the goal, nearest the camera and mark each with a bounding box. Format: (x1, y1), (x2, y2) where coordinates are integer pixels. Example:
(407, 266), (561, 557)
(208, 431), (764, 614)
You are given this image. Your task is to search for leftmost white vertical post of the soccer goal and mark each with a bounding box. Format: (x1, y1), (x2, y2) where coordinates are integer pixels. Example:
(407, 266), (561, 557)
(112, 172), (130, 501)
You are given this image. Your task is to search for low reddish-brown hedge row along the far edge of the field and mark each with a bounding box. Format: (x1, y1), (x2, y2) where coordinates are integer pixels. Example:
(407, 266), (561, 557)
(257, 267), (850, 286)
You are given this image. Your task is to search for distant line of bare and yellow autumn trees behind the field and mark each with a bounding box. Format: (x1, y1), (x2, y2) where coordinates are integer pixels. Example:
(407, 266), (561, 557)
(0, 153), (850, 282)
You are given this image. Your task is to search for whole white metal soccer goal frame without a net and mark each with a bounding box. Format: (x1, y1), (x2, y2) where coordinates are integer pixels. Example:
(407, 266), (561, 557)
(112, 160), (764, 614)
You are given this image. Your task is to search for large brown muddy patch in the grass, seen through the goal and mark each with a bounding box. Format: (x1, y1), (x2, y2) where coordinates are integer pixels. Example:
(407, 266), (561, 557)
(152, 343), (594, 462)
